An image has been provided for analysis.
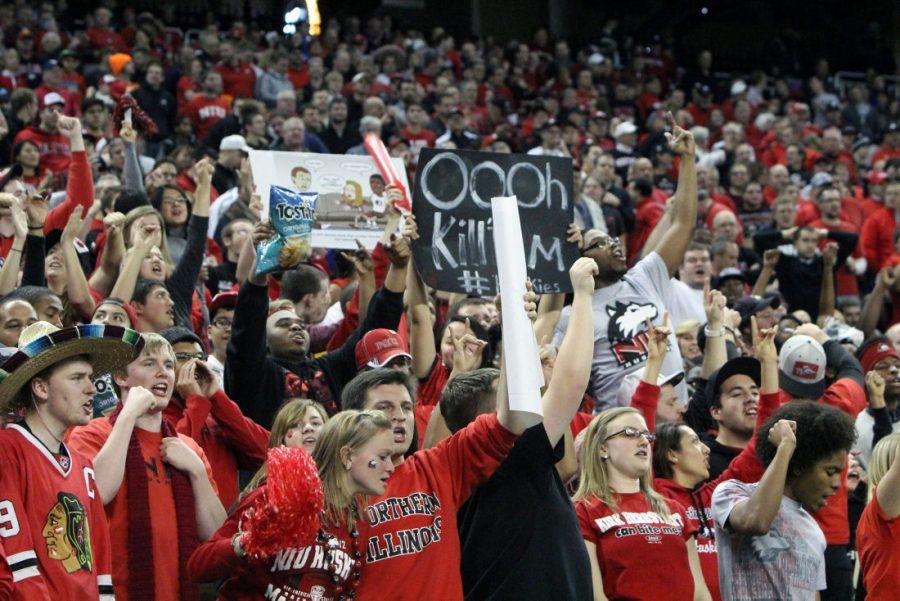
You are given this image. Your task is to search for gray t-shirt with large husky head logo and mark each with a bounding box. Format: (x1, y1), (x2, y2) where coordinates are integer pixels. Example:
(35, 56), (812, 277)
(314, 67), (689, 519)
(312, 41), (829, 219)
(553, 252), (687, 410)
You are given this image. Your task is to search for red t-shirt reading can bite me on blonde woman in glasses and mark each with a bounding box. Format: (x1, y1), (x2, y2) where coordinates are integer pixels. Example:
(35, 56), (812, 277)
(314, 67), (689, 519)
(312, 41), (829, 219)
(575, 492), (694, 601)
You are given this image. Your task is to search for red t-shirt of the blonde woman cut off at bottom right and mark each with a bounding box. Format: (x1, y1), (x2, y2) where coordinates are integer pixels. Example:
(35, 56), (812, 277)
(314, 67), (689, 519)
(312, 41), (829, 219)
(856, 488), (900, 601)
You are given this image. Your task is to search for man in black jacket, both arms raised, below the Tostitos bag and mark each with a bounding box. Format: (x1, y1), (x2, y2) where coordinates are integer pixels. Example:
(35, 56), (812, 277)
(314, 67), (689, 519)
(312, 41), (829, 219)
(225, 223), (410, 428)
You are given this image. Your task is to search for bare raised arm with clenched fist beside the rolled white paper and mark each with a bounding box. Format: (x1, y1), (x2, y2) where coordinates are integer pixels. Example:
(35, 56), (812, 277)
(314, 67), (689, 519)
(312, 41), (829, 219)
(541, 257), (597, 447)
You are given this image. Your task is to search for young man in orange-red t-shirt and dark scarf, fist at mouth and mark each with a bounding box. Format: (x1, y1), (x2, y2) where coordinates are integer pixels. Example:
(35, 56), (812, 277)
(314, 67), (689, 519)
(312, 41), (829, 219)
(69, 334), (226, 600)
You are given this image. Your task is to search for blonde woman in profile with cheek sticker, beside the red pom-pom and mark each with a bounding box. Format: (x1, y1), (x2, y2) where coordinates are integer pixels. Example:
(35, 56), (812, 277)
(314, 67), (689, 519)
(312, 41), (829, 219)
(188, 411), (394, 601)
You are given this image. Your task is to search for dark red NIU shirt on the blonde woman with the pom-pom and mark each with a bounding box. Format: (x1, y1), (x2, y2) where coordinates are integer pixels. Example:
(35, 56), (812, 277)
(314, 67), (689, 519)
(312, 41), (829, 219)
(188, 484), (366, 601)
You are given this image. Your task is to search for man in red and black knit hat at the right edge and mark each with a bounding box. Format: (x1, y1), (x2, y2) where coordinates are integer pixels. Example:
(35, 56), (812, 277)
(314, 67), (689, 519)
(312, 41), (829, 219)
(853, 336), (900, 468)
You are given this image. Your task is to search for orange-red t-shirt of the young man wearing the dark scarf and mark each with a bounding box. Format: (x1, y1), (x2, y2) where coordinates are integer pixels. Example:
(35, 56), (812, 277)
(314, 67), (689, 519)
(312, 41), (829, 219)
(69, 417), (218, 601)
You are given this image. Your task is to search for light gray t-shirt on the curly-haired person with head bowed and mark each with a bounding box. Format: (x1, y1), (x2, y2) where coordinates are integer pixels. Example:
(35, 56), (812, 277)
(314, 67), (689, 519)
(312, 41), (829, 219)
(711, 480), (826, 601)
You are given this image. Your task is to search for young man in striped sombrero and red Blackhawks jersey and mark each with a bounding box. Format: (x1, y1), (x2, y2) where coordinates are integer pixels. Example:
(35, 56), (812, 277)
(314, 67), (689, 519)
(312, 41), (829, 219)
(0, 321), (143, 601)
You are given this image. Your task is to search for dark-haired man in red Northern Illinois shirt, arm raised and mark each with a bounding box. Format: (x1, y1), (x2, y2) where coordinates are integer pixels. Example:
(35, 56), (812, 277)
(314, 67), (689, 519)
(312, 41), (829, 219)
(341, 282), (552, 601)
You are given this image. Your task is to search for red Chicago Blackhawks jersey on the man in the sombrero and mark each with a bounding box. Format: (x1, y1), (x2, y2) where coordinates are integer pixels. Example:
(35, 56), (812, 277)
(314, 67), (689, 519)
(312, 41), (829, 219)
(0, 424), (113, 601)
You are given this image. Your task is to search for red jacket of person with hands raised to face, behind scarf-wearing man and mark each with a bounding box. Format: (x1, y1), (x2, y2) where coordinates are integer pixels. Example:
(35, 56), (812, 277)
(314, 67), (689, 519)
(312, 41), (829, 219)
(163, 389), (269, 507)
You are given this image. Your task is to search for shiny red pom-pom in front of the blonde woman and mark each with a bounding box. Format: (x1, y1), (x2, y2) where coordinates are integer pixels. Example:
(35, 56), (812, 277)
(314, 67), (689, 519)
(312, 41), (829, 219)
(241, 447), (325, 557)
